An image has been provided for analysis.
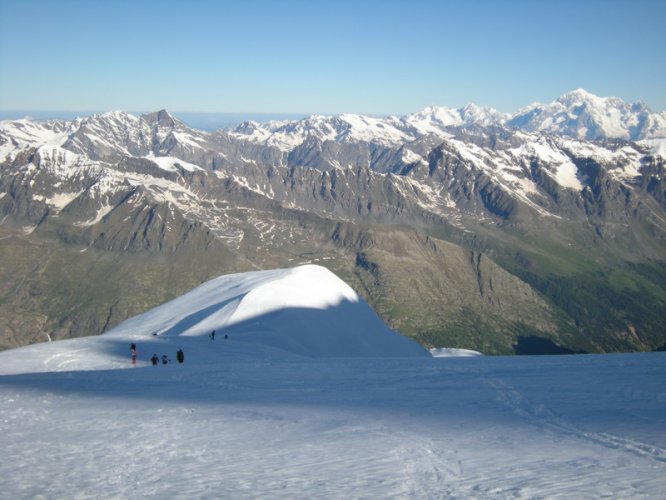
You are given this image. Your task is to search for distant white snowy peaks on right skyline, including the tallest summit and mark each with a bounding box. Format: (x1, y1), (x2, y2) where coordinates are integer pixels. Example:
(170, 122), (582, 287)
(232, 89), (666, 150)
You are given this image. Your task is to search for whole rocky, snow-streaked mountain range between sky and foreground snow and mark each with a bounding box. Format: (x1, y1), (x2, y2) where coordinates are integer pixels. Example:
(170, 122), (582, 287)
(0, 90), (666, 356)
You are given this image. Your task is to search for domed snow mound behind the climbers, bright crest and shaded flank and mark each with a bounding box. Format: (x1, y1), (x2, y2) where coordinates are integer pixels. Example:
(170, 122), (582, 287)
(113, 265), (426, 357)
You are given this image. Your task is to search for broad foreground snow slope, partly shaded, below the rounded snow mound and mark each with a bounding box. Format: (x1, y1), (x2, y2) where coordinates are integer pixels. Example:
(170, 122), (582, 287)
(0, 350), (666, 498)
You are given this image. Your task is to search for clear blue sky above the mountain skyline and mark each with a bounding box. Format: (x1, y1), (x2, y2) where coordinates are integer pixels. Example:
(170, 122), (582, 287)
(0, 0), (666, 115)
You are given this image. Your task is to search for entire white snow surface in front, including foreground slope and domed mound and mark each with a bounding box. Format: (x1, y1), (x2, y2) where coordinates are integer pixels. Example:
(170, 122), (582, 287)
(0, 266), (666, 498)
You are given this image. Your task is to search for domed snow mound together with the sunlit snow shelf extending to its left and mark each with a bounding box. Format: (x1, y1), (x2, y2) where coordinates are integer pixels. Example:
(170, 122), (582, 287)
(0, 265), (429, 373)
